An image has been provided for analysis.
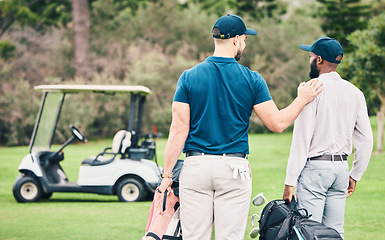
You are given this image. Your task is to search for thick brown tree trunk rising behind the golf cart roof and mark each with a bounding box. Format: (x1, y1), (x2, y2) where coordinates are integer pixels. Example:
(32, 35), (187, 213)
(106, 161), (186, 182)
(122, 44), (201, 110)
(71, 0), (91, 79)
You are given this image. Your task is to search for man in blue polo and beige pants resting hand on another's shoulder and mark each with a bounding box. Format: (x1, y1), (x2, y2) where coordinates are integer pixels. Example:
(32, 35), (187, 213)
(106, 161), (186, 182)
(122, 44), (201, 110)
(159, 15), (321, 240)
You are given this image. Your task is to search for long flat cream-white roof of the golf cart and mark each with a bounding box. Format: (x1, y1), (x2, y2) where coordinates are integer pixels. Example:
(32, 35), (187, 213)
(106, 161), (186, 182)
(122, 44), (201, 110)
(35, 85), (151, 95)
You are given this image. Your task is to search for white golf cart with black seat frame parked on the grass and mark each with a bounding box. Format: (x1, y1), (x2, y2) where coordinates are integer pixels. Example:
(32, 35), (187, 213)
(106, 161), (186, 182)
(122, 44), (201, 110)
(13, 85), (162, 202)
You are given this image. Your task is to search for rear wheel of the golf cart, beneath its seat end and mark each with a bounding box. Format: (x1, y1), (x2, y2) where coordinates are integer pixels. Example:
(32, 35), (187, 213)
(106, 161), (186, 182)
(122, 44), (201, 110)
(116, 178), (146, 202)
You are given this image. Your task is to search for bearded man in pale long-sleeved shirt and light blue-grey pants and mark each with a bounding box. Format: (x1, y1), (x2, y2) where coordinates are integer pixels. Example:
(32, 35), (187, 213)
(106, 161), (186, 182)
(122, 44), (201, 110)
(283, 37), (373, 237)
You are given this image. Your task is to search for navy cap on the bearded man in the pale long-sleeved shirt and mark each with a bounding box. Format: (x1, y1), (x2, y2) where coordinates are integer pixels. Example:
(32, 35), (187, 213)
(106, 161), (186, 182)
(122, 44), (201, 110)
(299, 37), (343, 64)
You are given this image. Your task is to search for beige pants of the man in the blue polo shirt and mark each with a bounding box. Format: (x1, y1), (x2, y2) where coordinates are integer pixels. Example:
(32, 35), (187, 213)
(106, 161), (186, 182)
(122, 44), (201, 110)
(179, 155), (251, 240)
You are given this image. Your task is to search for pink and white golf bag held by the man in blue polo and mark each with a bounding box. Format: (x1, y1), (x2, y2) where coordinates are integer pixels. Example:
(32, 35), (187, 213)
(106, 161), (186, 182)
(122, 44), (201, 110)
(142, 160), (183, 240)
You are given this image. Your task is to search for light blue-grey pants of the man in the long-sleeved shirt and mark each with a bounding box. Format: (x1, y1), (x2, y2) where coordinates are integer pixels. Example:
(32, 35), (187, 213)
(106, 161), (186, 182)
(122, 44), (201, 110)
(296, 160), (349, 237)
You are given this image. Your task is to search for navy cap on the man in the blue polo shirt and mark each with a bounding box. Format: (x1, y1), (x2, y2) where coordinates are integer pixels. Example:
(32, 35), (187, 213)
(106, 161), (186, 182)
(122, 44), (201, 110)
(213, 14), (257, 39)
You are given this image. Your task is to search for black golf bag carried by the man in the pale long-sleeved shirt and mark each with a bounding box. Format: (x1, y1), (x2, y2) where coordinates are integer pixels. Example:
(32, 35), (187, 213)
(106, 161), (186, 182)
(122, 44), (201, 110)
(259, 199), (342, 240)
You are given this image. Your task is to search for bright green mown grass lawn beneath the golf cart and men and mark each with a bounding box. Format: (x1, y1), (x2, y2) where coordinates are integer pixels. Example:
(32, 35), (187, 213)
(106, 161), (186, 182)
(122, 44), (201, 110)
(0, 130), (385, 240)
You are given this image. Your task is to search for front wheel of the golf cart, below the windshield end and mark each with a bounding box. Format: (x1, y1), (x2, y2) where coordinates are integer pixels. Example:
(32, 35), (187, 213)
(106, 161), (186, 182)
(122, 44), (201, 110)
(13, 176), (42, 203)
